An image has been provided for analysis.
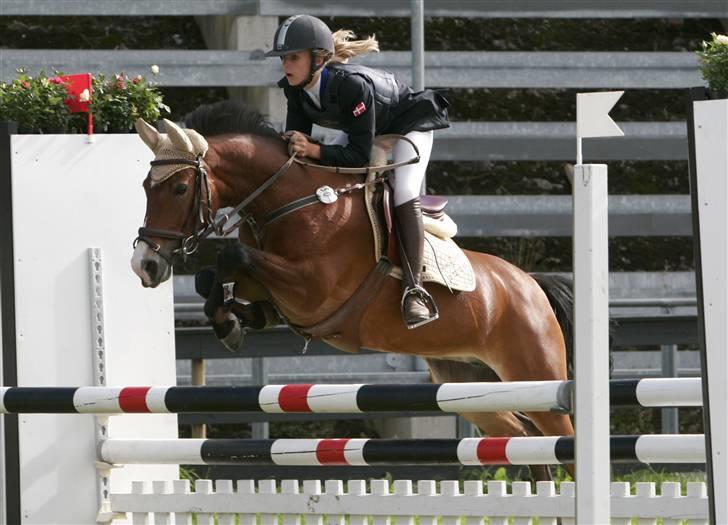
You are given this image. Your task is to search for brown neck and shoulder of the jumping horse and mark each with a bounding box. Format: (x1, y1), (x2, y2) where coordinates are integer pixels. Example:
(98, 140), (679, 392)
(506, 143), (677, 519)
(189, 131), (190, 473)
(213, 136), (375, 325)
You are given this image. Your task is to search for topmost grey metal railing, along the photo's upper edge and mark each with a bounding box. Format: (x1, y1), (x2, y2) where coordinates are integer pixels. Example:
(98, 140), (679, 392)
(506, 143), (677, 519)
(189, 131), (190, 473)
(0, 0), (728, 18)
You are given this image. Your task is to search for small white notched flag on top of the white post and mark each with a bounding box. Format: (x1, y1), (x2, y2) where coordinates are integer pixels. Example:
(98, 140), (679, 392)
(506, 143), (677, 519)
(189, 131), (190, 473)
(576, 91), (624, 164)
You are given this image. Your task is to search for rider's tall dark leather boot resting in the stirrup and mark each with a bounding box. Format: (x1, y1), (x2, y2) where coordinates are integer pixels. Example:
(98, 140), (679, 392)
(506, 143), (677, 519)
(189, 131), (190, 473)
(395, 197), (438, 329)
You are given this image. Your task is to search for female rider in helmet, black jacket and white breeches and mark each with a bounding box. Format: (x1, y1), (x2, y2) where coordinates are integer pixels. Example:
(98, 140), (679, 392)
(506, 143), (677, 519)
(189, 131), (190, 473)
(266, 15), (450, 328)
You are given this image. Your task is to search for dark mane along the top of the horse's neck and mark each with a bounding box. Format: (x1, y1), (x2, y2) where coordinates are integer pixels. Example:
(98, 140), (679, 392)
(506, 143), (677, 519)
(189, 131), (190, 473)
(184, 100), (280, 139)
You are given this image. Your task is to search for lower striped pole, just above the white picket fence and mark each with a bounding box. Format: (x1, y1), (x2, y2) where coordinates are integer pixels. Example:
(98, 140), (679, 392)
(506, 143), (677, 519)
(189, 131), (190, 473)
(99, 434), (705, 464)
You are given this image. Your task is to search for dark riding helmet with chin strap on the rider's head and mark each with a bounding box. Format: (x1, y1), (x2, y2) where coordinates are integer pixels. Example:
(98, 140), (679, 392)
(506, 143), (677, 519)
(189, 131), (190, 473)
(265, 15), (334, 85)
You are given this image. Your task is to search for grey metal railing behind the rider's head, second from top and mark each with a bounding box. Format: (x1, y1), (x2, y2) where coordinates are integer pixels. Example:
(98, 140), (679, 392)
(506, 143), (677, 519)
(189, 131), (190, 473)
(0, 49), (704, 89)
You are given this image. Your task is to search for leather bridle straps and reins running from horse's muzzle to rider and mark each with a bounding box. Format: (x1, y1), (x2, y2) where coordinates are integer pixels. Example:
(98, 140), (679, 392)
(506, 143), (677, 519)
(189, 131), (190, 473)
(133, 136), (420, 265)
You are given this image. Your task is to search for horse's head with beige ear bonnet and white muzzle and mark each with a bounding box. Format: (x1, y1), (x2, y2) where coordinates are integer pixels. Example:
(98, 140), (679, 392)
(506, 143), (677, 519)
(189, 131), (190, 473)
(131, 119), (215, 288)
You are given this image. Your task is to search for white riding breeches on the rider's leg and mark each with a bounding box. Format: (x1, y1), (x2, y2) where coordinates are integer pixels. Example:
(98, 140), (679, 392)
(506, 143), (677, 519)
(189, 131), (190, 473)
(332, 131), (433, 206)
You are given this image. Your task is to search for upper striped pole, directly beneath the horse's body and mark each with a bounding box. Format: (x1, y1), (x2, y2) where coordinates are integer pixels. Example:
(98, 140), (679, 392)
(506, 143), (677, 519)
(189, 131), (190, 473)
(0, 377), (702, 414)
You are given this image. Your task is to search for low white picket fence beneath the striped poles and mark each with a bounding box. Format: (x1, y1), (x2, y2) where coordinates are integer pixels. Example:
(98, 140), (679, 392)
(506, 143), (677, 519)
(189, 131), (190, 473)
(111, 480), (708, 525)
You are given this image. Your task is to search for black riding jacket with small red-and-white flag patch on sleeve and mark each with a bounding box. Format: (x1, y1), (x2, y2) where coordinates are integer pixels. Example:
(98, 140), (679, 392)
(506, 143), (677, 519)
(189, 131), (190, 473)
(278, 64), (450, 167)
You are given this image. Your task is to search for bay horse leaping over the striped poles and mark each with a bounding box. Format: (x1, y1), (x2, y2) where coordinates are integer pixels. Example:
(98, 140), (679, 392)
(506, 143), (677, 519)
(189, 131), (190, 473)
(132, 103), (574, 479)
